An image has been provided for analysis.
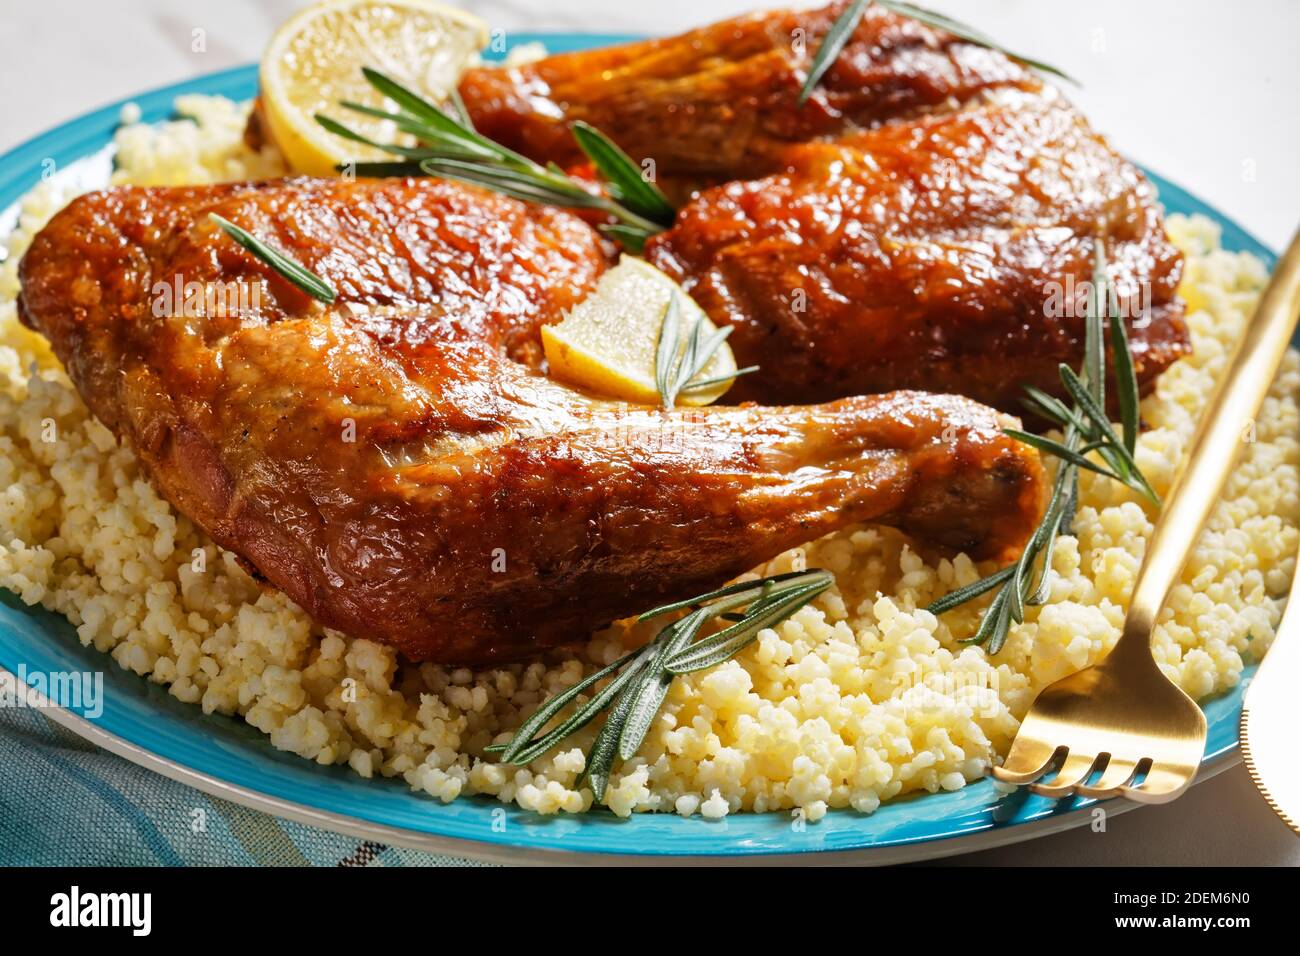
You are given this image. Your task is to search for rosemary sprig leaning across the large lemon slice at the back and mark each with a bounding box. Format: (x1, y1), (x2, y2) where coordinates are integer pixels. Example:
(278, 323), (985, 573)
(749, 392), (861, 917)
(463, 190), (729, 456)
(316, 68), (676, 252)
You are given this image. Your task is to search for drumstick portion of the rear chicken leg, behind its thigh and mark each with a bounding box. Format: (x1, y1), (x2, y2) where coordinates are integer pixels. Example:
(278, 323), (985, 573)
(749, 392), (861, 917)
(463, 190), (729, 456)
(460, 3), (1040, 181)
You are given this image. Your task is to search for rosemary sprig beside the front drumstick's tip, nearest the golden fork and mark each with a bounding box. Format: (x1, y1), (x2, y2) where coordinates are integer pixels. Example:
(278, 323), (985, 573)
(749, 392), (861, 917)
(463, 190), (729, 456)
(927, 241), (1160, 654)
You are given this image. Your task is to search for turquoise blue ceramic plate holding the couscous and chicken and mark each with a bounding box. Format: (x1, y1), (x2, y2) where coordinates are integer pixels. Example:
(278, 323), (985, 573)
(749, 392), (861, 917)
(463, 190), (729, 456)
(0, 34), (1274, 864)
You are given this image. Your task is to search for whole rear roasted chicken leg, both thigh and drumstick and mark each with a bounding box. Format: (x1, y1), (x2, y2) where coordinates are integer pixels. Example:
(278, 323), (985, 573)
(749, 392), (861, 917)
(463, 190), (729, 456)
(462, 4), (1190, 411)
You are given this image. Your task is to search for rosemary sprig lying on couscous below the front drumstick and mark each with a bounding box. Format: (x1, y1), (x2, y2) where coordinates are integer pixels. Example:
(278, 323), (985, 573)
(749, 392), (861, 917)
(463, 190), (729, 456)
(485, 568), (833, 801)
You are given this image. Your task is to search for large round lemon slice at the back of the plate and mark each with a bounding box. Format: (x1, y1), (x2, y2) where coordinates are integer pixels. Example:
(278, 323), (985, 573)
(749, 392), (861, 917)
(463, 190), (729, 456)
(259, 0), (488, 176)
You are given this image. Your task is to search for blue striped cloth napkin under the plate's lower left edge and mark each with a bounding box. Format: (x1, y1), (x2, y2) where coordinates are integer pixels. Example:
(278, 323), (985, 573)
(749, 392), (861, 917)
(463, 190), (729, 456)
(0, 708), (480, 866)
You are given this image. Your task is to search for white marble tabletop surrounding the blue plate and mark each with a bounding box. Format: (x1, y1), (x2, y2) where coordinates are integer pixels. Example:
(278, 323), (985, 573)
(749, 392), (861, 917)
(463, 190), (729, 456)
(0, 0), (1300, 865)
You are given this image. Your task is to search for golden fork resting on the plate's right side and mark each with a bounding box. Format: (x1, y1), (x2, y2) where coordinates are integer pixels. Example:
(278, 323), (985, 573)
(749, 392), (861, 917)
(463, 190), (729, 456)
(993, 233), (1300, 804)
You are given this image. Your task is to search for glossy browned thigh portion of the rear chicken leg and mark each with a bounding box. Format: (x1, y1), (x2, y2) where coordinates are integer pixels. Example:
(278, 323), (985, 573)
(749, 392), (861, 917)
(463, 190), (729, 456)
(646, 92), (1188, 411)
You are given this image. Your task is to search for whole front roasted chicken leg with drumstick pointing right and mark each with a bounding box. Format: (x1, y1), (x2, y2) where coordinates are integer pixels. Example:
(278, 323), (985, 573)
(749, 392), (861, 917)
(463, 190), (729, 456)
(20, 179), (1044, 663)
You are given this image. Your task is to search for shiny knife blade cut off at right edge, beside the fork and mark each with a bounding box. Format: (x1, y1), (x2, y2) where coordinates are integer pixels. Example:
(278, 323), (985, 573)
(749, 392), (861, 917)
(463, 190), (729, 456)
(1240, 575), (1300, 834)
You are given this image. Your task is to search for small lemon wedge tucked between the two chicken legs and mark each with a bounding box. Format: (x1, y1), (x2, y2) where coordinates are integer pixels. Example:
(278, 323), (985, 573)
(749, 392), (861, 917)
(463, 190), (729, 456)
(542, 256), (736, 405)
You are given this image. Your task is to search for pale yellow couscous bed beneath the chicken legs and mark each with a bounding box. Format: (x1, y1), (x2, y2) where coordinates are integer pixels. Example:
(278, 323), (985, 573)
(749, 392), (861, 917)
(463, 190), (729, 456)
(0, 96), (1284, 821)
